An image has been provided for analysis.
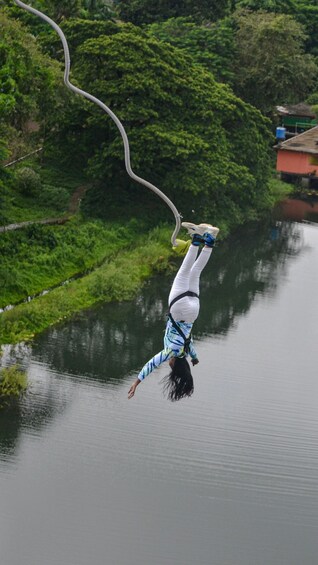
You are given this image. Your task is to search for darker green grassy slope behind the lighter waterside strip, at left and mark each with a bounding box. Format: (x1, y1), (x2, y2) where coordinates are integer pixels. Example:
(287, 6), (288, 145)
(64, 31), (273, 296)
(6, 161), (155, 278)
(0, 217), (144, 308)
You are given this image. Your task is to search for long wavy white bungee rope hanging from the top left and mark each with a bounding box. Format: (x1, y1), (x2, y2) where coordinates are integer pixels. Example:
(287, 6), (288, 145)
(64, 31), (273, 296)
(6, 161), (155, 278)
(14, 0), (181, 246)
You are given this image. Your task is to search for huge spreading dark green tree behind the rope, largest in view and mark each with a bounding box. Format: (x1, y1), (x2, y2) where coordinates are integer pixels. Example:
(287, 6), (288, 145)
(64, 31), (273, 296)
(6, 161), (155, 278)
(44, 22), (271, 225)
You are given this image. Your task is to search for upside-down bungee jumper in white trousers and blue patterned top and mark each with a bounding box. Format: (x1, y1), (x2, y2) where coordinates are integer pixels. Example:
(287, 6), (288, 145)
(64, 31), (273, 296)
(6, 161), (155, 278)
(128, 222), (219, 401)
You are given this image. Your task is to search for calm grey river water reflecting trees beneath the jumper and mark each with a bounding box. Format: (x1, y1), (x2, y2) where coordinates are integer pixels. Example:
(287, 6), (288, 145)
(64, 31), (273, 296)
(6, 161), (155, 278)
(0, 214), (318, 565)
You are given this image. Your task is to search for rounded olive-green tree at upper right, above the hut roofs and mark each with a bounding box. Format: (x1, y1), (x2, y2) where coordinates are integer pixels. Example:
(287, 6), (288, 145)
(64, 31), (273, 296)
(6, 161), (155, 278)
(231, 10), (318, 113)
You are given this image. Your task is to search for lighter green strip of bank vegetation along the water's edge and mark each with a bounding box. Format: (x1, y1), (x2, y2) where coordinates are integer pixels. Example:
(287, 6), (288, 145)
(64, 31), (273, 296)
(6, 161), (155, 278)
(0, 228), (173, 345)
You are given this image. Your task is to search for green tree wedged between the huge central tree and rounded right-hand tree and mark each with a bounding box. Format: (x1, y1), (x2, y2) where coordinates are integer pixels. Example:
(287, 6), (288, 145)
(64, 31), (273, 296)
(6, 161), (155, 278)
(147, 18), (234, 83)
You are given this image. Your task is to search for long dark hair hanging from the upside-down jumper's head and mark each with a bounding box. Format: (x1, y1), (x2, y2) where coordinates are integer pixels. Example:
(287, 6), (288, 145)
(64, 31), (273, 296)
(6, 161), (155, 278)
(162, 357), (194, 402)
